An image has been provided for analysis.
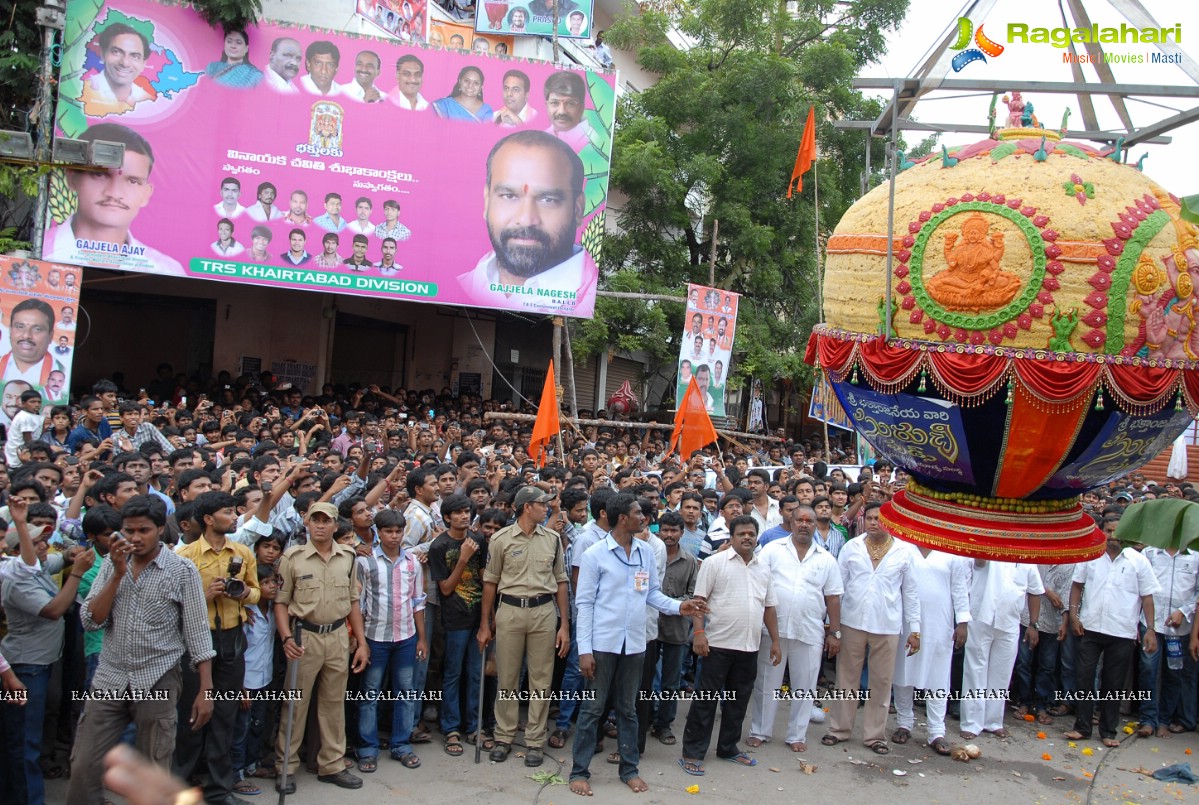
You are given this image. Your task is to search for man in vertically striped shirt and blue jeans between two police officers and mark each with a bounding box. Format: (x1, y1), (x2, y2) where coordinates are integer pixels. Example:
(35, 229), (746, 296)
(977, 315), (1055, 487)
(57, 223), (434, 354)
(357, 509), (428, 773)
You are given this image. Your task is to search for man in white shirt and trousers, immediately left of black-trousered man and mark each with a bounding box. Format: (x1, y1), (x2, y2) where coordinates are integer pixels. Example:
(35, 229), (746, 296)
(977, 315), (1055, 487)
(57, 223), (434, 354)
(962, 559), (1046, 740)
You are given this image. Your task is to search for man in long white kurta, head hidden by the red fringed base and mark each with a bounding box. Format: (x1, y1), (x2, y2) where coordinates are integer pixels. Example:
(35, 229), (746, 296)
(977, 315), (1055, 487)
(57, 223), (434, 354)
(891, 546), (971, 755)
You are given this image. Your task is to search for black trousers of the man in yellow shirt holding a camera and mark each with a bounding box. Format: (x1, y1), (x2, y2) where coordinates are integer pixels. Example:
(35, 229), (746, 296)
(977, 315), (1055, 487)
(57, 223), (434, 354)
(171, 626), (246, 803)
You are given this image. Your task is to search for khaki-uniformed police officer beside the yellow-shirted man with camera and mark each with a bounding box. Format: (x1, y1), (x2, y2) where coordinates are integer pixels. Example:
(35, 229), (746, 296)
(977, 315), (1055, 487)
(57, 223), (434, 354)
(275, 503), (370, 794)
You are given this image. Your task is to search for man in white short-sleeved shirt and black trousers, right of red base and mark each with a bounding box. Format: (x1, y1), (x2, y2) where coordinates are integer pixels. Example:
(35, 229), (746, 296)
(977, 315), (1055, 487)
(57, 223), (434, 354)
(1065, 515), (1161, 747)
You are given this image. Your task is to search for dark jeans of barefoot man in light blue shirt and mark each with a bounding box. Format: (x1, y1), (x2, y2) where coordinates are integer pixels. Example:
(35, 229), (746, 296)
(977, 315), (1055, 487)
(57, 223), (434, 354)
(571, 651), (645, 782)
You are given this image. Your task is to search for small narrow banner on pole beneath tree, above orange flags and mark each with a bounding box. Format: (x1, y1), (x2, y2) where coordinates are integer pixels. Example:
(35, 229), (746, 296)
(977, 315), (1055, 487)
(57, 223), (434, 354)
(675, 284), (741, 416)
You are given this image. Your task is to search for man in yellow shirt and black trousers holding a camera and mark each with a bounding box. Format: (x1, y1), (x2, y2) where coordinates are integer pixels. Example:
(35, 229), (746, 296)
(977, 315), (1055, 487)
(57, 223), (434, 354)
(173, 492), (260, 805)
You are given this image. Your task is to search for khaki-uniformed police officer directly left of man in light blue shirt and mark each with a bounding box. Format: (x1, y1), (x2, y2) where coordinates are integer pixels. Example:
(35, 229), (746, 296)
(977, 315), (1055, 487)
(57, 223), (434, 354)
(478, 486), (571, 767)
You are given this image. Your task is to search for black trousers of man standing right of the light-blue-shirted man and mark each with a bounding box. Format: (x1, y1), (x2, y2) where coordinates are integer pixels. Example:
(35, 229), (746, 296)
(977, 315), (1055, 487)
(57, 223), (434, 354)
(682, 648), (758, 761)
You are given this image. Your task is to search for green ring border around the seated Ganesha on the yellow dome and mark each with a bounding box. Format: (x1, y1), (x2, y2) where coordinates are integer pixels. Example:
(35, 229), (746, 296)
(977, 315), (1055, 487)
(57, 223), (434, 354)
(908, 202), (1047, 330)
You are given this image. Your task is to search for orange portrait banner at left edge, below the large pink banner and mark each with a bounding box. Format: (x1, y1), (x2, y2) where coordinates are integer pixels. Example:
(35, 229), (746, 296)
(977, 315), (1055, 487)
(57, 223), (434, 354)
(0, 257), (80, 427)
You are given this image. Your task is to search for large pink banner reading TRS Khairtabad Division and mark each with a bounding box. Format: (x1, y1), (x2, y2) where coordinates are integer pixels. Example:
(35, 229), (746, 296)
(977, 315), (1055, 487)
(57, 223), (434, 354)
(44, 0), (615, 317)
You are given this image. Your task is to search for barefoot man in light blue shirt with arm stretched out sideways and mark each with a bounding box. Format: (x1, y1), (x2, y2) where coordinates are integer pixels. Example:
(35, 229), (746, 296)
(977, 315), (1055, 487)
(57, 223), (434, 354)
(571, 493), (701, 797)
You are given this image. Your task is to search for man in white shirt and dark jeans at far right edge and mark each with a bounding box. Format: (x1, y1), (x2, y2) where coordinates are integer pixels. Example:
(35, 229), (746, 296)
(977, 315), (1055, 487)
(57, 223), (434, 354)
(1136, 542), (1199, 738)
